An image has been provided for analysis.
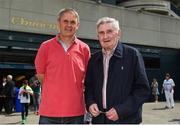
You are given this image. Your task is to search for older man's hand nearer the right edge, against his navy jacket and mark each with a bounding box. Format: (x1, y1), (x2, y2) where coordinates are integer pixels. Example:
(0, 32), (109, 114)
(106, 108), (119, 121)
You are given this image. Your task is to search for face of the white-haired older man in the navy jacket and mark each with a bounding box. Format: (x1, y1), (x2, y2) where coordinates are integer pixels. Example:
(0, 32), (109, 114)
(97, 23), (120, 50)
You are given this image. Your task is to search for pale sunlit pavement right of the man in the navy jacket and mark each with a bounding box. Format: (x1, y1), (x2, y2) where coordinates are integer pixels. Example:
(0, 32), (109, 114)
(143, 102), (180, 124)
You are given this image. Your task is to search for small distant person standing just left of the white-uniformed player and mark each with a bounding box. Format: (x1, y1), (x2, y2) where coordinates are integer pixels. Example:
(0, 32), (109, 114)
(151, 78), (159, 102)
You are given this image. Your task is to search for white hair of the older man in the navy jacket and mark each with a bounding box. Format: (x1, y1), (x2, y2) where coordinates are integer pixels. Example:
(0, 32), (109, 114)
(96, 17), (121, 30)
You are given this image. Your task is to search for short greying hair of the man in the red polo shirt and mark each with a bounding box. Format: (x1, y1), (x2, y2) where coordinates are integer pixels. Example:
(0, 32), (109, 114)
(58, 8), (80, 23)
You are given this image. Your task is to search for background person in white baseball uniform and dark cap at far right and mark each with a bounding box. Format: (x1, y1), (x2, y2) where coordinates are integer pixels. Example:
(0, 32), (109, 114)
(163, 73), (175, 108)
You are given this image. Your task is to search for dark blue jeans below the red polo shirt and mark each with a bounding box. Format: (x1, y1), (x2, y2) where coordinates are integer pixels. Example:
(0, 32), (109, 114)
(39, 115), (84, 124)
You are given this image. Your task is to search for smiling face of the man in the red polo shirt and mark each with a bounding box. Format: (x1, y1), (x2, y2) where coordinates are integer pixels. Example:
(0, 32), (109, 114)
(58, 12), (79, 37)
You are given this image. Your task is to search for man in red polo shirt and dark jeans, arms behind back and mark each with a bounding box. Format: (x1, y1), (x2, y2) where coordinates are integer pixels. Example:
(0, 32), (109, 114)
(35, 8), (90, 124)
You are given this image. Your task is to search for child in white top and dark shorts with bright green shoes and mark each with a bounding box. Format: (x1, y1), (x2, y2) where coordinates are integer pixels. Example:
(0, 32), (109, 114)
(19, 79), (33, 124)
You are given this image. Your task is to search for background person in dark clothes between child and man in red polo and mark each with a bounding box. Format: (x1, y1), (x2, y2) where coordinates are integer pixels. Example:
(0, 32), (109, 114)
(29, 75), (41, 115)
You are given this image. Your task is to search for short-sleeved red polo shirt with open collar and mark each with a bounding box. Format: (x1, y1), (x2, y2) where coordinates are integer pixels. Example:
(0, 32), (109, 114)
(35, 37), (90, 117)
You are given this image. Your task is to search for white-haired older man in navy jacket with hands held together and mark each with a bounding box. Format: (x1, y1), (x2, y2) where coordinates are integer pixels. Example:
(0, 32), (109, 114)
(85, 17), (150, 124)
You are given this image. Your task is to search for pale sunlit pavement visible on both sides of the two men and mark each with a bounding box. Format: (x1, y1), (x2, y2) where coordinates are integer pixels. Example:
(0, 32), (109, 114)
(0, 102), (180, 124)
